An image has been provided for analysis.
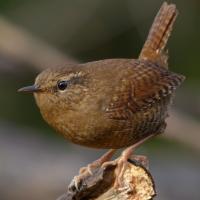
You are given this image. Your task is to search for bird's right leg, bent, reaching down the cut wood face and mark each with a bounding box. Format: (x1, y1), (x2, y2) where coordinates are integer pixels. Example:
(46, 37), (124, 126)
(114, 135), (154, 188)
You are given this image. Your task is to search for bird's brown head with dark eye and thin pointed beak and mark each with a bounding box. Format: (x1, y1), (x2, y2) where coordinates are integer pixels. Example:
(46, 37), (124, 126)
(18, 66), (88, 115)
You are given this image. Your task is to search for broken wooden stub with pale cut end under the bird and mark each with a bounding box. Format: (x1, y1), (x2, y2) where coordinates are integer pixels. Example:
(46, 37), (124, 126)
(57, 156), (156, 200)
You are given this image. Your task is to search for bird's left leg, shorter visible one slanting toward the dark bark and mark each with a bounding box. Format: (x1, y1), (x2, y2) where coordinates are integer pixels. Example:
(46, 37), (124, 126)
(79, 149), (117, 175)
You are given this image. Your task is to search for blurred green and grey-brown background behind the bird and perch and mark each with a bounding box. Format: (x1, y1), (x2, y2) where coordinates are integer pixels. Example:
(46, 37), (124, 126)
(0, 0), (200, 200)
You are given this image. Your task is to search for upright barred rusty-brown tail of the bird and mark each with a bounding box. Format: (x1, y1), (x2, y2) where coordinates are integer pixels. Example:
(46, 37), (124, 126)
(139, 2), (178, 68)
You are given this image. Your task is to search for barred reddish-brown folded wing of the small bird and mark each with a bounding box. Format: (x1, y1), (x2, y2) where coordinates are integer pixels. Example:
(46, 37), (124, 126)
(106, 63), (184, 120)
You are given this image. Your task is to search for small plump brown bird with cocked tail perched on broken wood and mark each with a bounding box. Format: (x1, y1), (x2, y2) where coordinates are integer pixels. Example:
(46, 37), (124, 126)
(19, 2), (184, 188)
